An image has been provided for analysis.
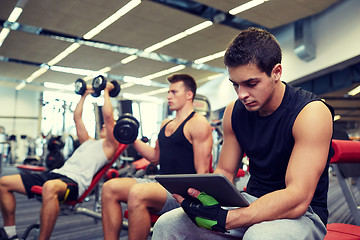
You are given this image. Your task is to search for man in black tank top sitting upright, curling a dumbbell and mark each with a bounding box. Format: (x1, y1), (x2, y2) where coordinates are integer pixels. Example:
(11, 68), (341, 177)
(101, 74), (212, 240)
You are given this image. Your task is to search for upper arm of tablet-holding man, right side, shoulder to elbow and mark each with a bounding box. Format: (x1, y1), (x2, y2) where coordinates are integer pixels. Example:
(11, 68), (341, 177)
(286, 101), (332, 197)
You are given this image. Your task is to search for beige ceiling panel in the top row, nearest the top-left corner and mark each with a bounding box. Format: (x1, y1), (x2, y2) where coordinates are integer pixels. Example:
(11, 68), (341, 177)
(18, 0), (128, 36)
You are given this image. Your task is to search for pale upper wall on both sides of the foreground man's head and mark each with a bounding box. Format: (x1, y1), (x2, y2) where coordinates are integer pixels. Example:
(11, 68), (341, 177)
(198, 0), (360, 110)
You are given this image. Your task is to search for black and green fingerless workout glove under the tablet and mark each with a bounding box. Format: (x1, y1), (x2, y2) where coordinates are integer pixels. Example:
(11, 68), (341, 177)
(181, 192), (228, 232)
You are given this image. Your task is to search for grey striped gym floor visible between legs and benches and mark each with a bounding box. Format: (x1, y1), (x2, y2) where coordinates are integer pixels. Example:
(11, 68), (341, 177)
(0, 166), (360, 240)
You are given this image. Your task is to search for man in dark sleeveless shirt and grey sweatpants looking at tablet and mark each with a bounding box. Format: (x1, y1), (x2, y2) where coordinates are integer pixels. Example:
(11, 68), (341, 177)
(153, 28), (333, 240)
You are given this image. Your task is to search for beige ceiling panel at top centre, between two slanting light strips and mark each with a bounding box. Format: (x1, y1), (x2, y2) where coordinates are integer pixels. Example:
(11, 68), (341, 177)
(94, 1), (204, 49)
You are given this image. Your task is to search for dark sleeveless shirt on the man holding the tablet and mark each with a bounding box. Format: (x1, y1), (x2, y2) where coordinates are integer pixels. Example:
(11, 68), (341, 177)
(231, 85), (333, 224)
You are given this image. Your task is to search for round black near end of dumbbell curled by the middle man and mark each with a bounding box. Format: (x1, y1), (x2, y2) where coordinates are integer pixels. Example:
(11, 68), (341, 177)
(113, 113), (139, 144)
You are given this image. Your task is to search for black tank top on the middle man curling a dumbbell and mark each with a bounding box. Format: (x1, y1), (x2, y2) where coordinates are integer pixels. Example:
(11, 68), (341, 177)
(158, 112), (196, 174)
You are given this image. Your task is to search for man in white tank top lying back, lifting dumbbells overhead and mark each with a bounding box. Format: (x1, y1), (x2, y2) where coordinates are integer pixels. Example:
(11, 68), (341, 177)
(0, 83), (119, 240)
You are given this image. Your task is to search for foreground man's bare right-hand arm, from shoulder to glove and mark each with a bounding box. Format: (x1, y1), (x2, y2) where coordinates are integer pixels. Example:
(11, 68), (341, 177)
(226, 101), (332, 229)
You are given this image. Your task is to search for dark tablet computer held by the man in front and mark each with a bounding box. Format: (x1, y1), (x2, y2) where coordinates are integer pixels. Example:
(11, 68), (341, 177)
(155, 174), (249, 207)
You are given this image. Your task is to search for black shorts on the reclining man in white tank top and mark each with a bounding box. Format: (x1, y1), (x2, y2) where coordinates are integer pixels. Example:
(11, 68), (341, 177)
(20, 172), (79, 201)
